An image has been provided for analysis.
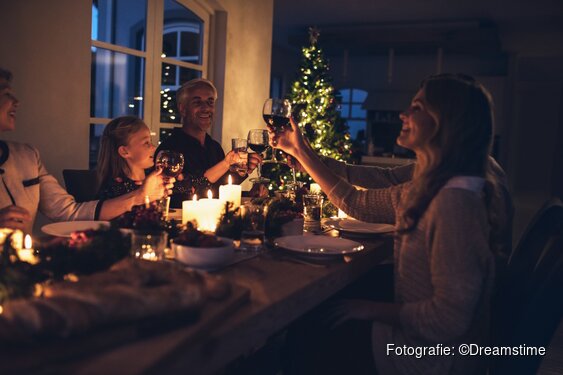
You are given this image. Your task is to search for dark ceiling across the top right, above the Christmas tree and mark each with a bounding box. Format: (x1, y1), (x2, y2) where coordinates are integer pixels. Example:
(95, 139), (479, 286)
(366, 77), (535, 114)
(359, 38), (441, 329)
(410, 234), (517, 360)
(274, 0), (563, 55)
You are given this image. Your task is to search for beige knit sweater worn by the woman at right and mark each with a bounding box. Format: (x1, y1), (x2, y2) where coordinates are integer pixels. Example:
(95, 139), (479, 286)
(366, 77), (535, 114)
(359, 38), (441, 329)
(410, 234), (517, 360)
(328, 177), (494, 375)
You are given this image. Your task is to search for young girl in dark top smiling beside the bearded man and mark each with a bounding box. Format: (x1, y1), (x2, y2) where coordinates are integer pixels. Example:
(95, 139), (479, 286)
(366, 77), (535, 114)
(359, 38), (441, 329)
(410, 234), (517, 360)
(97, 116), (173, 199)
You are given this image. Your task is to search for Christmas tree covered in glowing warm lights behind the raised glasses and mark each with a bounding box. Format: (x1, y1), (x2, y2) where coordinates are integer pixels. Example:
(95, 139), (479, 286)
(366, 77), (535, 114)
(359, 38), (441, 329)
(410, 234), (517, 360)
(264, 28), (352, 190)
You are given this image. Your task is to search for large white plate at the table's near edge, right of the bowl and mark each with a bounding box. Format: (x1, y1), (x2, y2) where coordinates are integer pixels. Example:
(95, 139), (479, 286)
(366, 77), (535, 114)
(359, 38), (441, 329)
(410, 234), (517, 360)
(274, 235), (364, 256)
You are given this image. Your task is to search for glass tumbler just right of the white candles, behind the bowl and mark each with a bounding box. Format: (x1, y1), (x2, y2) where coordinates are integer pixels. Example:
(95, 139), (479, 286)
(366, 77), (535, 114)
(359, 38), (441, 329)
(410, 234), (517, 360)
(240, 202), (266, 251)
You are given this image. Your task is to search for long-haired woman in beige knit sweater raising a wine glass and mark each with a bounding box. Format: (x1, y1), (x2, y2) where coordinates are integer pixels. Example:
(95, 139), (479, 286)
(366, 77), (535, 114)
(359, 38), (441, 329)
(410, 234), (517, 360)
(271, 75), (499, 374)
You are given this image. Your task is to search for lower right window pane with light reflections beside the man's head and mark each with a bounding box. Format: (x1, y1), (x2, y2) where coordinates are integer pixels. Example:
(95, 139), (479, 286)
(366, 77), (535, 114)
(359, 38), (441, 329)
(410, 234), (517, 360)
(160, 64), (201, 123)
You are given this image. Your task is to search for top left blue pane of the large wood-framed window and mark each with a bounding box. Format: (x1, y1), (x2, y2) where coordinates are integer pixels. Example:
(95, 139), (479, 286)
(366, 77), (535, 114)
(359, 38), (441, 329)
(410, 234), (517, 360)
(92, 0), (147, 51)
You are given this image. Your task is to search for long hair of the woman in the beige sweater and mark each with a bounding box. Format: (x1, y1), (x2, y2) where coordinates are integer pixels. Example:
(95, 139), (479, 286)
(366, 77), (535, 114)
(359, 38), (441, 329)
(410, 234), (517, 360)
(402, 74), (493, 232)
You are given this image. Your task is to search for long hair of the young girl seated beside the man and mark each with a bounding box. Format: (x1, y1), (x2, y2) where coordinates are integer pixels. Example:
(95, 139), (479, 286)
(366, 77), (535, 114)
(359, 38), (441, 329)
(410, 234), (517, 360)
(97, 116), (147, 194)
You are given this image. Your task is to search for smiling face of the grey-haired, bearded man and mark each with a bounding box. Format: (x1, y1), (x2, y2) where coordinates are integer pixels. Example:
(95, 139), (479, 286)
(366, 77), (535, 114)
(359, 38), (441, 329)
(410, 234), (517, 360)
(180, 86), (215, 132)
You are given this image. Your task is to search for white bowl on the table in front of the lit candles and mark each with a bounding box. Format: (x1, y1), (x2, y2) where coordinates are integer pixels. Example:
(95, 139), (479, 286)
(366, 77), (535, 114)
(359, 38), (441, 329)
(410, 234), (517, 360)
(171, 237), (235, 269)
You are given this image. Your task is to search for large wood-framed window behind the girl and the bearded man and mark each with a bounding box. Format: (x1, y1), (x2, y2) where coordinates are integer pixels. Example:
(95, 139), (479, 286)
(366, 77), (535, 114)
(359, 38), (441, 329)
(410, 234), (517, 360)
(90, 0), (211, 167)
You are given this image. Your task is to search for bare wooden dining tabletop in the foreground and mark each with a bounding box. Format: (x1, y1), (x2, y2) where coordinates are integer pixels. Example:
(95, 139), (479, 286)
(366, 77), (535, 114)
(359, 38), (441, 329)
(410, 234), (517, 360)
(2, 222), (393, 374)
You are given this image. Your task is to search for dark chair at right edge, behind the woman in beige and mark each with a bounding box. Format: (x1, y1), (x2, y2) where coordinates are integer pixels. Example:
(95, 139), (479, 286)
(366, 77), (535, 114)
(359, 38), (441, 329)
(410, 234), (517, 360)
(491, 199), (563, 374)
